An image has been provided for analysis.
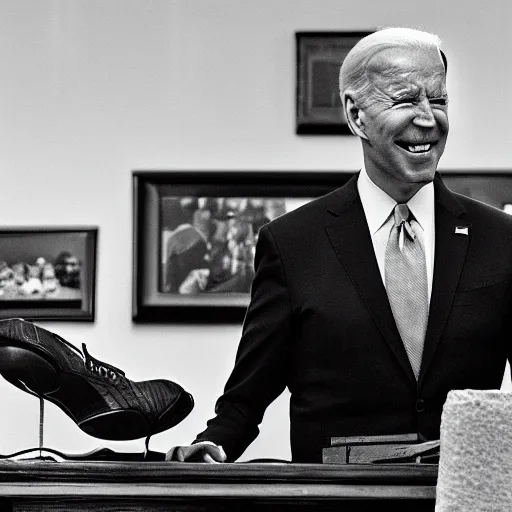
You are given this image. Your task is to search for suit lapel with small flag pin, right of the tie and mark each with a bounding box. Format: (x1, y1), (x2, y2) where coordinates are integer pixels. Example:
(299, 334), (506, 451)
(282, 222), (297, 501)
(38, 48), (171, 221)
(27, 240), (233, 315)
(420, 175), (471, 384)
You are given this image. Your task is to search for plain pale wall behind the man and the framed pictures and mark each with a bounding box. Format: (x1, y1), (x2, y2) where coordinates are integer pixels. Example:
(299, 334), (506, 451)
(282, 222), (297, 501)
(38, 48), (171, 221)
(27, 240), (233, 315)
(0, 0), (512, 458)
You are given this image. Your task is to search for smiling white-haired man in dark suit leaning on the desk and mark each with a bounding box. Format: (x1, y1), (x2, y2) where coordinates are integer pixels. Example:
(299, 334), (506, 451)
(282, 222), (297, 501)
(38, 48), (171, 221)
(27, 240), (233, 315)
(168, 29), (512, 462)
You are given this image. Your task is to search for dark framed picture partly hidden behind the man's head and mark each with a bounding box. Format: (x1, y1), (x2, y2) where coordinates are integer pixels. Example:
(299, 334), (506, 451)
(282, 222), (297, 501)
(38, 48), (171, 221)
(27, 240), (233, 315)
(295, 31), (372, 135)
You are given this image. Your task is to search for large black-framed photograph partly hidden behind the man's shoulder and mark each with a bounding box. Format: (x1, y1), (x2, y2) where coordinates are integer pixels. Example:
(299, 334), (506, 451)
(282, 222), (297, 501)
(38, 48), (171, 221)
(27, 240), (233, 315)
(132, 171), (352, 323)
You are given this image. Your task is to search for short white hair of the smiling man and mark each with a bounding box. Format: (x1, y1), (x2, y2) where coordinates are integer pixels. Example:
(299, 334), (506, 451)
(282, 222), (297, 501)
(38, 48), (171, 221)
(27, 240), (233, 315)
(340, 27), (446, 114)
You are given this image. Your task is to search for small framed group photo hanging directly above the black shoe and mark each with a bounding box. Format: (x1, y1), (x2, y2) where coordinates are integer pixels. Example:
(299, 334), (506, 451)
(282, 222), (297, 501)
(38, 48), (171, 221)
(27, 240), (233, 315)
(0, 227), (98, 322)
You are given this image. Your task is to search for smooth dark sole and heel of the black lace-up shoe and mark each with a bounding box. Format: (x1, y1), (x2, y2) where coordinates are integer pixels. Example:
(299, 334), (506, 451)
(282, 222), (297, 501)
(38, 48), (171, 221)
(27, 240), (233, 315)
(0, 340), (193, 441)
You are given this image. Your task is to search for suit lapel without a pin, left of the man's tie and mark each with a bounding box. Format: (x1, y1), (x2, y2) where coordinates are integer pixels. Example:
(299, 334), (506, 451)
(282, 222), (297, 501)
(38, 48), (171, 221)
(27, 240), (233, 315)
(326, 175), (416, 383)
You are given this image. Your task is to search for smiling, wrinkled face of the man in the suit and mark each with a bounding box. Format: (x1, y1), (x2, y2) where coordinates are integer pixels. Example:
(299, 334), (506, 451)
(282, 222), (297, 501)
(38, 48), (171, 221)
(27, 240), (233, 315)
(359, 45), (449, 187)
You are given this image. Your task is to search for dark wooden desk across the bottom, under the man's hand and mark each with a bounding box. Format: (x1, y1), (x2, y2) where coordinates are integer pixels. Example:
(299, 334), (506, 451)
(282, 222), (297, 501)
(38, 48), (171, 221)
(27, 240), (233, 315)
(0, 461), (437, 512)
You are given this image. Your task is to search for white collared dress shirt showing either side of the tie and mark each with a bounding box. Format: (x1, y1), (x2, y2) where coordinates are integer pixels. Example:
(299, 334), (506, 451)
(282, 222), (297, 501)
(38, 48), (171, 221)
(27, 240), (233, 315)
(357, 166), (435, 302)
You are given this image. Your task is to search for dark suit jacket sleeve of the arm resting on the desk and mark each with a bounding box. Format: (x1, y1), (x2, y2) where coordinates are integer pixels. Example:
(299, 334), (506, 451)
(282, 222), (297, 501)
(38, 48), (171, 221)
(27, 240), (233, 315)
(195, 225), (292, 461)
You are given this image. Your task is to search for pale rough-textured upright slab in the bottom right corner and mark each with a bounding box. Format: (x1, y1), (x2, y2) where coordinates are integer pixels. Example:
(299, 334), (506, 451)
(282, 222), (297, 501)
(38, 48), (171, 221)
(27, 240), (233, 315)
(436, 389), (512, 512)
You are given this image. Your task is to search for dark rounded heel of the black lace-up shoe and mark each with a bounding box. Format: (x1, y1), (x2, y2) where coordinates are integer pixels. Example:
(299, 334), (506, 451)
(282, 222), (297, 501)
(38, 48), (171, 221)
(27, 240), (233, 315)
(0, 345), (58, 396)
